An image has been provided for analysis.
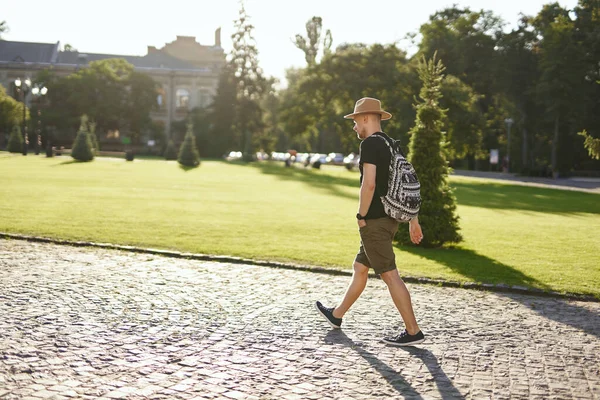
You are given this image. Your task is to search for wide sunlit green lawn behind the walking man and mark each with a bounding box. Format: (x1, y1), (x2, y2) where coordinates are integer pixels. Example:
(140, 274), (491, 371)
(0, 153), (600, 298)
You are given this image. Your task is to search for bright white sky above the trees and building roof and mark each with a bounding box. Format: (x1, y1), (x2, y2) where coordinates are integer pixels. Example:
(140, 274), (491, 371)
(0, 0), (577, 85)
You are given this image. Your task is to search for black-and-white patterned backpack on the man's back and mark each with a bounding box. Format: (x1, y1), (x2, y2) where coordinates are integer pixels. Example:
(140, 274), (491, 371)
(374, 135), (421, 222)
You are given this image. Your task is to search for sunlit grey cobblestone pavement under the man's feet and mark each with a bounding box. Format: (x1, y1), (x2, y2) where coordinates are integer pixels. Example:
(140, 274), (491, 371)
(0, 240), (600, 399)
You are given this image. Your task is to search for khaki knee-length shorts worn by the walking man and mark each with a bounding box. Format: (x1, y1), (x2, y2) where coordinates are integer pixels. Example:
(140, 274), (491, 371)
(354, 217), (398, 275)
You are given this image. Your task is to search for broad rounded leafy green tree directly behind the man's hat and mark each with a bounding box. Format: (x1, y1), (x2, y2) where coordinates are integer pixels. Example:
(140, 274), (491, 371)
(279, 44), (418, 153)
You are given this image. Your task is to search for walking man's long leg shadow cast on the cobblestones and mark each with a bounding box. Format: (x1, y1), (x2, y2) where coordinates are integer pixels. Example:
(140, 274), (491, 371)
(324, 329), (465, 399)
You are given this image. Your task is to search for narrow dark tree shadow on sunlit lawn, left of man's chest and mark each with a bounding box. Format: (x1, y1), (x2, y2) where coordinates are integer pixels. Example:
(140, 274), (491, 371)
(250, 162), (360, 200)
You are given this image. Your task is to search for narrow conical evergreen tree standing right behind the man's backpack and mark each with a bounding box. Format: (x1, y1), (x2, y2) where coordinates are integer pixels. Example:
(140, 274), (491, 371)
(396, 55), (462, 247)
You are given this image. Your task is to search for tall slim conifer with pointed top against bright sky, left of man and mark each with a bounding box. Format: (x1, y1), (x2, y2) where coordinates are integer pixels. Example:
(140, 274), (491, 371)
(229, 4), (272, 161)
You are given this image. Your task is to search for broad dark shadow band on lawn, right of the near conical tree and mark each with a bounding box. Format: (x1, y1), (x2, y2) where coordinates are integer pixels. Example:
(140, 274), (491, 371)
(451, 182), (600, 214)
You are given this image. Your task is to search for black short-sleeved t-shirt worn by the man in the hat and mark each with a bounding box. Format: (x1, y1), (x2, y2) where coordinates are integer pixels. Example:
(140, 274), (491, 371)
(358, 132), (391, 219)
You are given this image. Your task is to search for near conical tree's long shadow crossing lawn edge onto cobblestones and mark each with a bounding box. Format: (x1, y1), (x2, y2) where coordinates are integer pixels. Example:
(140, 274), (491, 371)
(398, 246), (600, 337)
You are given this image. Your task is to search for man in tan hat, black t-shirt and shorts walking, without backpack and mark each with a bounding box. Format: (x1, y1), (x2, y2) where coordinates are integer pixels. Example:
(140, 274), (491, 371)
(315, 97), (425, 346)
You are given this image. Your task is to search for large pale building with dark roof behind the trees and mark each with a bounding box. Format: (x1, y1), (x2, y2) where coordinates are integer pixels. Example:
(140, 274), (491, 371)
(0, 28), (225, 134)
